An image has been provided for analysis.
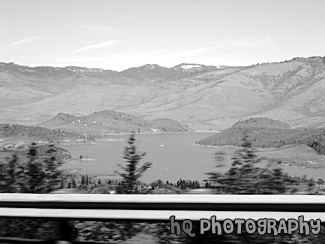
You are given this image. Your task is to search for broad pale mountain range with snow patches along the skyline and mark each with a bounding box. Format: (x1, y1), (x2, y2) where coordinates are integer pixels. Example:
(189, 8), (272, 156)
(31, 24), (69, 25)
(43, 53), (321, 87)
(0, 57), (325, 130)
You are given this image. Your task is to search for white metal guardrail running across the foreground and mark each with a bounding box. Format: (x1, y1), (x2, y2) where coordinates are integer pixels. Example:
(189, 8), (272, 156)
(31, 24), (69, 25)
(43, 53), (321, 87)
(0, 193), (325, 243)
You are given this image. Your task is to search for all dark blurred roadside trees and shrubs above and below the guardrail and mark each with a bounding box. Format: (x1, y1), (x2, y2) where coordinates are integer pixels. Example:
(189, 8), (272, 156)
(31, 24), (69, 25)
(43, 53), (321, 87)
(0, 134), (324, 243)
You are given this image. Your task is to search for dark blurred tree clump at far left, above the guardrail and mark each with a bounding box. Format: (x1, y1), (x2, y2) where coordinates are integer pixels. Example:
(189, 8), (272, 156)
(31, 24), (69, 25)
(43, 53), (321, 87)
(0, 143), (64, 193)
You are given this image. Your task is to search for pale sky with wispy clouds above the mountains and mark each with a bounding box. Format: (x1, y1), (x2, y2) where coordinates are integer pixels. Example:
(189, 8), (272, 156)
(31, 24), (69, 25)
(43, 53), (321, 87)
(0, 0), (325, 71)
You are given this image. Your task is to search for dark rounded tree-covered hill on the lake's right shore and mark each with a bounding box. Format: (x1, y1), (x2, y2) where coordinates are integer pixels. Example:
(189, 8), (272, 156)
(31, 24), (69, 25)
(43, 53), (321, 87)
(197, 118), (325, 154)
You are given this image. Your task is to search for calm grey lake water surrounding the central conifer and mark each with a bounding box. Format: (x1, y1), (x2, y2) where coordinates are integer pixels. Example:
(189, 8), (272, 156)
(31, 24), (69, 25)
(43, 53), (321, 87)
(62, 132), (216, 183)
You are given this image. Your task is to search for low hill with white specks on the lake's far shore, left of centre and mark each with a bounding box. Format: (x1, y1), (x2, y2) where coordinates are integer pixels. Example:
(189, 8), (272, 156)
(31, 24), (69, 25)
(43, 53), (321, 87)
(40, 110), (190, 133)
